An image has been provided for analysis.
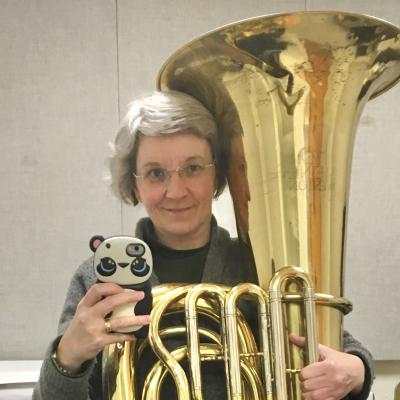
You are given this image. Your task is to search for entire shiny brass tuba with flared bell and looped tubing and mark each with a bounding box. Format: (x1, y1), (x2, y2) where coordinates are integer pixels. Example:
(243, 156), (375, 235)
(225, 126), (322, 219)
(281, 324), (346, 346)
(103, 12), (400, 400)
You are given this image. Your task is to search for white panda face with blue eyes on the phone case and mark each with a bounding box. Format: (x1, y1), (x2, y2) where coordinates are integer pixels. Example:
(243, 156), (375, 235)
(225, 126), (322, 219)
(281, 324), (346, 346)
(90, 236), (153, 285)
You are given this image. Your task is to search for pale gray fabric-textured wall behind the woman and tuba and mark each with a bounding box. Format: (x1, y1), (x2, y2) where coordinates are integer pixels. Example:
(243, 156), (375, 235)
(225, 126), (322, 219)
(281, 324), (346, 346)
(0, 0), (400, 360)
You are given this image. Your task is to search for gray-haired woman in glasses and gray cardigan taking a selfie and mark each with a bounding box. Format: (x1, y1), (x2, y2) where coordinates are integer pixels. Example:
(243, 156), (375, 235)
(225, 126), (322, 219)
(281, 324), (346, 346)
(34, 92), (371, 400)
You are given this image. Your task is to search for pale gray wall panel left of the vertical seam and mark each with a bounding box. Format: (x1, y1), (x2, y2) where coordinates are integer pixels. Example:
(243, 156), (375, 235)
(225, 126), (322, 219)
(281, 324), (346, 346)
(0, 0), (120, 359)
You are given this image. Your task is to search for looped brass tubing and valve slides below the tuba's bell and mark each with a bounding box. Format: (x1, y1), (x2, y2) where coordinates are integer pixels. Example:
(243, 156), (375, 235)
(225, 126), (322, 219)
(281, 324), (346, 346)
(103, 274), (318, 400)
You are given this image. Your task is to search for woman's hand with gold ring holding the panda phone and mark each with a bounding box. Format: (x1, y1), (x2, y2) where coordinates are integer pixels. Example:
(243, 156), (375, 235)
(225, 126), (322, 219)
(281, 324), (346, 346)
(57, 283), (150, 372)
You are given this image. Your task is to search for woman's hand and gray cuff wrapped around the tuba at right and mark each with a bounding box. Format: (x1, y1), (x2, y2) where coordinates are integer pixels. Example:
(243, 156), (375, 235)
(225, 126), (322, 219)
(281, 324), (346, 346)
(290, 333), (372, 400)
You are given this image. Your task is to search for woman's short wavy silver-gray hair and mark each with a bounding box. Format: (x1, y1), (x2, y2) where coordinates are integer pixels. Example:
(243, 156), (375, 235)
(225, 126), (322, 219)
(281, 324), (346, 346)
(110, 91), (226, 205)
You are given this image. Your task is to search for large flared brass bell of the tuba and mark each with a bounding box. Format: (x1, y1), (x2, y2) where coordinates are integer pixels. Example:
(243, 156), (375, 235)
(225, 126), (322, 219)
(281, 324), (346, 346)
(158, 12), (400, 349)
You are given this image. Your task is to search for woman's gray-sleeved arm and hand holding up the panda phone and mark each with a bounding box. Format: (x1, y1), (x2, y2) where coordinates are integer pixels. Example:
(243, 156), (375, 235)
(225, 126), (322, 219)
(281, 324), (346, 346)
(33, 264), (148, 400)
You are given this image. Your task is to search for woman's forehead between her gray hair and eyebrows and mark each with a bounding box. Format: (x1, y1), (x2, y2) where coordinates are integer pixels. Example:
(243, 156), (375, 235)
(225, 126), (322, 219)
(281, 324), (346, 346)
(136, 132), (211, 166)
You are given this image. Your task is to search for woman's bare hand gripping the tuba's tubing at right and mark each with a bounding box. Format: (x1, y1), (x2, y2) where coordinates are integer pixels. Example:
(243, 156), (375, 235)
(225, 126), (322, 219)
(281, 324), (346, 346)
(289, 334), (365, 400)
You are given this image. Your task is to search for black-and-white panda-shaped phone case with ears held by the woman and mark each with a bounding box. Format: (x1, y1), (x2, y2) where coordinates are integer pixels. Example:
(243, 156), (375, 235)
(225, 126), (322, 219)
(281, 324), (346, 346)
(90, 235), (153, 338)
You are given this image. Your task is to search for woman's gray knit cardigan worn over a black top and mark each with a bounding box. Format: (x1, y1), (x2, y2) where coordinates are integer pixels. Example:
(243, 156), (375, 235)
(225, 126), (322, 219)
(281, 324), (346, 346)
(33, 219), (373, 400)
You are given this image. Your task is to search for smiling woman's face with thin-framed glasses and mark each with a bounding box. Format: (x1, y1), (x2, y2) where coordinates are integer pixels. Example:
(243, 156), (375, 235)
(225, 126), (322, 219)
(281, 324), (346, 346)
(135, 131), (215, 249)
